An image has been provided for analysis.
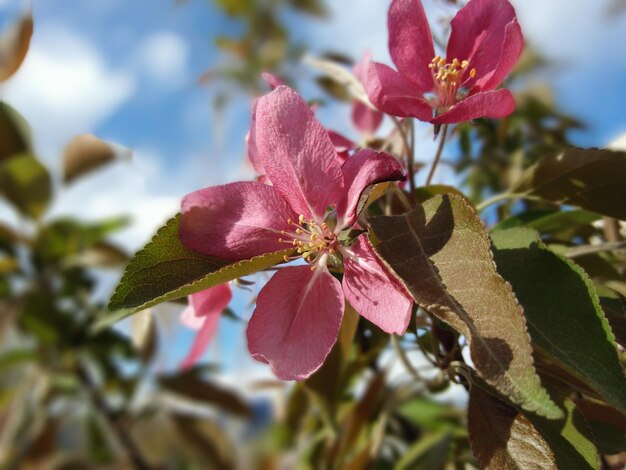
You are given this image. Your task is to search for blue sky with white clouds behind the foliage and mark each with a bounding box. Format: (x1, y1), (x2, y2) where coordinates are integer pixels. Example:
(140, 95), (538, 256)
(0, 0), (626, 384)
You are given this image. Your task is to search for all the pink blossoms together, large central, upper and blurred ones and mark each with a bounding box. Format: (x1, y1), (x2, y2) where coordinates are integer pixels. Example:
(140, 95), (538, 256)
(180, 0), (523, 380)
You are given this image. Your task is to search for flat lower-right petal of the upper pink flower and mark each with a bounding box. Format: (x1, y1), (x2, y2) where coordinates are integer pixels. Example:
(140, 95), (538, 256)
(431, 88), (515, 124)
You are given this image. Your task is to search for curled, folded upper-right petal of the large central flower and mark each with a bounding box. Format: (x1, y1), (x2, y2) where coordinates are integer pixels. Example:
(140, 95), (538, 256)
(337, 149), (404, 226)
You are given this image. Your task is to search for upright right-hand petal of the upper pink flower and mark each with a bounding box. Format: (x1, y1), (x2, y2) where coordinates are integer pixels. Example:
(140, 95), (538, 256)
(447, 0), (521, 88)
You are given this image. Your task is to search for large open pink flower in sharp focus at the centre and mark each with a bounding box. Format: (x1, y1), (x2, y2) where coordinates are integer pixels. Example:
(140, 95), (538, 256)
(180, 86), (412, 380)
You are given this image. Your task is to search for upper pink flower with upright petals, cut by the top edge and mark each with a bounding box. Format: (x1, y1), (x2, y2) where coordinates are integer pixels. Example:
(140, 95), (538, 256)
(366, 0), (523, 124)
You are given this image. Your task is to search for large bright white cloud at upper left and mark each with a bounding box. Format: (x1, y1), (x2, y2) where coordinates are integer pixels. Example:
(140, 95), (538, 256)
(4, 25), (135, 167)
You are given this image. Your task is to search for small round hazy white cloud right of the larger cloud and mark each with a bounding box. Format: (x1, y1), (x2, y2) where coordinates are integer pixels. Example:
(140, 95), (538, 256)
(138, 32), (189, 84)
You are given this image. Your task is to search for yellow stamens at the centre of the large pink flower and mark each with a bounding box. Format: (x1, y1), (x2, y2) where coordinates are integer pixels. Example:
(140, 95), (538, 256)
(278, 215), (339, 270)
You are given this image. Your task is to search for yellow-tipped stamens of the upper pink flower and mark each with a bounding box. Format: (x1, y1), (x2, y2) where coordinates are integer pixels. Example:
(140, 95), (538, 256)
(428, 56), (476, 109)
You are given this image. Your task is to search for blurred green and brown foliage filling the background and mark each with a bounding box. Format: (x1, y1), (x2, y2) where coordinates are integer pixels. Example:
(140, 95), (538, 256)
(0, 0), (626, 469)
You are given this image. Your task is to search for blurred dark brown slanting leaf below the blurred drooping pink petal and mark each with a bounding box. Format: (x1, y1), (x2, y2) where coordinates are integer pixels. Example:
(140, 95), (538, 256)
(159, 368), (251, 417)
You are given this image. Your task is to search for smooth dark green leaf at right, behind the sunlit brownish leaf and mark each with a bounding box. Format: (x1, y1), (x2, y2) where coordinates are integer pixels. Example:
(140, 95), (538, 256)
(492, 229), (626, 410)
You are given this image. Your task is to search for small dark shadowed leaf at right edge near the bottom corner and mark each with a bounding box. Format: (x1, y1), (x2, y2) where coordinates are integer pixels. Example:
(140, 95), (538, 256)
(575, 399), (626, 454)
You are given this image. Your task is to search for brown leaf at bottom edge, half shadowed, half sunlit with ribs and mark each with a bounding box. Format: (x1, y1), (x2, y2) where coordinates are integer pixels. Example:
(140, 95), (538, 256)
(467, 386), (558, 470)
